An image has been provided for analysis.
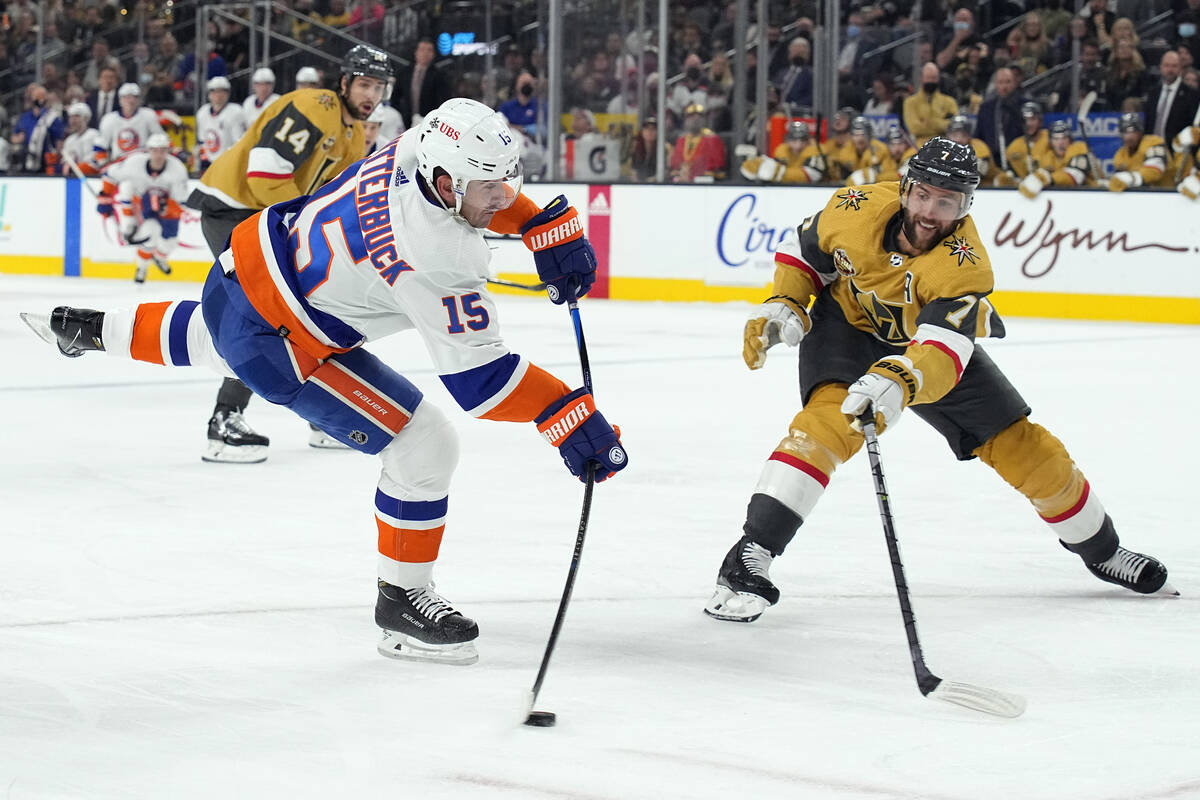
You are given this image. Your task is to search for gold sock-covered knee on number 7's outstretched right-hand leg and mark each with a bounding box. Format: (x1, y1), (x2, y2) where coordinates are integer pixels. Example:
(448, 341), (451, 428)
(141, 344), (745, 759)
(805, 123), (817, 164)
(974, 417), (1084, 517)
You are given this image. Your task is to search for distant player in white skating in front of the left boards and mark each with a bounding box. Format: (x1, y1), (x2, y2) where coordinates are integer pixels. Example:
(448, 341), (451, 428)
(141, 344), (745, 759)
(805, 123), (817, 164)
(104, 133), (187, 283)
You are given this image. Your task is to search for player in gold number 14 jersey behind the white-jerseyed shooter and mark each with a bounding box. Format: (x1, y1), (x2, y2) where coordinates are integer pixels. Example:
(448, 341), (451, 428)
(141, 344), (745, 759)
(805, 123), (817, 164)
(187, 44), (392, 463)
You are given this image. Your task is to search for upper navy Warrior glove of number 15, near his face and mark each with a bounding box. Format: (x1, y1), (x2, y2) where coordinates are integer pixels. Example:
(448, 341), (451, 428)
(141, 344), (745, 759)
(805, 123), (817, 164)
(521, 194), (596, 303)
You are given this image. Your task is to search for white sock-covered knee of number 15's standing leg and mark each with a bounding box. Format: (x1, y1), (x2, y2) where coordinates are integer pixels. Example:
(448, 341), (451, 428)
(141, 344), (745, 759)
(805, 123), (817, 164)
(379, 401), (458, 500)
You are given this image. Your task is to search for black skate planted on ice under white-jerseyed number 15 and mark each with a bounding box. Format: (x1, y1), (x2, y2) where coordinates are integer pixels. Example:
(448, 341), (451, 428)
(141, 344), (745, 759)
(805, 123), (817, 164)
(376, 581), (479, 664)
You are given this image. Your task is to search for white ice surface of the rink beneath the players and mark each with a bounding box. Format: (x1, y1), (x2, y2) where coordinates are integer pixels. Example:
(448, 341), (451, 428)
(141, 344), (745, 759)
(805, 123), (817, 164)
(0, 276), (1200, 800)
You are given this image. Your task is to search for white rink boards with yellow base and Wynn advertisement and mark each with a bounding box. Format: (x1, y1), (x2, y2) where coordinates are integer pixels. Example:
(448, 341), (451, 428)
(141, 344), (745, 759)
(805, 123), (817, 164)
(0, 178), (1200, 324)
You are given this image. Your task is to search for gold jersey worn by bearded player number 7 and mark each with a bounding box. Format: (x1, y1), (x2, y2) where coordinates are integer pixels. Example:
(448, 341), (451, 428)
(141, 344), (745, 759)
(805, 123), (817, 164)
(774, 182), (1004, 404)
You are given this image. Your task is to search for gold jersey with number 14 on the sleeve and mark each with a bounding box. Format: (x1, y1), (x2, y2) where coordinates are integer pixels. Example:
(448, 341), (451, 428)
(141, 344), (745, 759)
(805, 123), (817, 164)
(192, 89), (366, 209)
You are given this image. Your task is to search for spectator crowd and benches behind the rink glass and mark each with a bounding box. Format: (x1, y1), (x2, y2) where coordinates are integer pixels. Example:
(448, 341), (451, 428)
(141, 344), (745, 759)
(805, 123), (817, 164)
(0, 0), (1200, 197)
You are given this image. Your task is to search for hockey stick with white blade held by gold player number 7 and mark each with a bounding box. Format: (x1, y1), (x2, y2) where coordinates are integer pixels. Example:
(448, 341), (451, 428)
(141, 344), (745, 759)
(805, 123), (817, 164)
(859, 410), (1025, 717)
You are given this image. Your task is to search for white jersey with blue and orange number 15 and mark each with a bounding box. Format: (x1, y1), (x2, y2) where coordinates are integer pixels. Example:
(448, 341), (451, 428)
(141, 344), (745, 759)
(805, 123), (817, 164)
(221, 134), (568, 421)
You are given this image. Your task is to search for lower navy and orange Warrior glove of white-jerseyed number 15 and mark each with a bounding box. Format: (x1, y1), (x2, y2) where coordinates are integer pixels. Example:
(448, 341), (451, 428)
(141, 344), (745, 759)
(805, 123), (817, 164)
(534, 389), (629, 482)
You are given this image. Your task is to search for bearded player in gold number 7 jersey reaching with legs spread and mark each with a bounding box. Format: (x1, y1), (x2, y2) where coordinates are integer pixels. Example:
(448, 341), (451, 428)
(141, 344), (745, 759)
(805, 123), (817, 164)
(704, 138), (1172, 622)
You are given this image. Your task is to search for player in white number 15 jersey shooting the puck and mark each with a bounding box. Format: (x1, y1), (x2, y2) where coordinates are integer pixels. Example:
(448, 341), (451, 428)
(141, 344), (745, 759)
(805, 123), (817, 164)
(23, 98), (628, 663)
